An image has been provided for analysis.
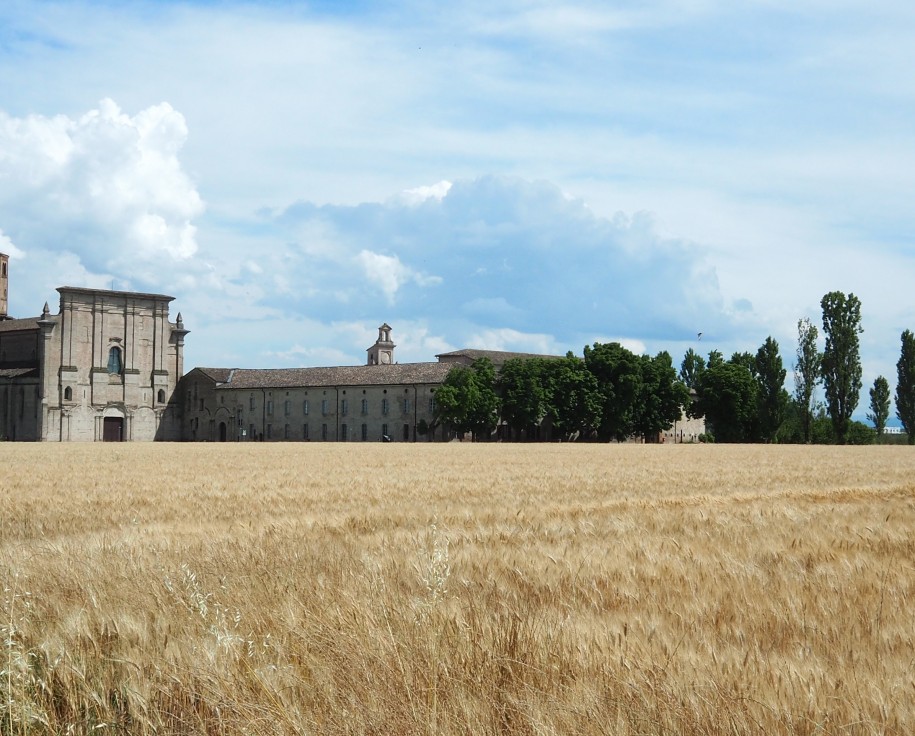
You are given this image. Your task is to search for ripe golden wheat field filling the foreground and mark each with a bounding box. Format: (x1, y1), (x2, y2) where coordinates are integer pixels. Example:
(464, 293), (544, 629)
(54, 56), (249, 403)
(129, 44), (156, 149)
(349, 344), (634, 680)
(0, 444), (915, 735)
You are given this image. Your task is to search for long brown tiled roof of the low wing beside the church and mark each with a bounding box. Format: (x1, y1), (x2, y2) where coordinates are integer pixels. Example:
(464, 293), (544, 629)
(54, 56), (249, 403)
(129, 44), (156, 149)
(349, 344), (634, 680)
(212, 363), (454, 389)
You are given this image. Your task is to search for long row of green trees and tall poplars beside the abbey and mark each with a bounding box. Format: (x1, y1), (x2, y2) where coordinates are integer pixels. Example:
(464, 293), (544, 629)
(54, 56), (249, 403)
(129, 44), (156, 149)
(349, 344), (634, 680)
(432, 291), (915, 444)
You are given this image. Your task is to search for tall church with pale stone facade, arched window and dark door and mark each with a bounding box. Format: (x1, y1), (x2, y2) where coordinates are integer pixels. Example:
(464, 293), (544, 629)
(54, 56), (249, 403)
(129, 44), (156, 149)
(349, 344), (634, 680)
(0, 268), (187, 442)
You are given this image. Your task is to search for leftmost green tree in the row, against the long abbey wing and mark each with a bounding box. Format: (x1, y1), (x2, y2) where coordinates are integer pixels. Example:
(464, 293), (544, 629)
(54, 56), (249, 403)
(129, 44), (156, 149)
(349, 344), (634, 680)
(435, 358), (499, 439)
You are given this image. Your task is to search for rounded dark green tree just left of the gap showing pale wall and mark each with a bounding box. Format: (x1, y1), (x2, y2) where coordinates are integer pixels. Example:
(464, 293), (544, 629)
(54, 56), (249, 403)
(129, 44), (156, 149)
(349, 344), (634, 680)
(633, 351), (690, 442)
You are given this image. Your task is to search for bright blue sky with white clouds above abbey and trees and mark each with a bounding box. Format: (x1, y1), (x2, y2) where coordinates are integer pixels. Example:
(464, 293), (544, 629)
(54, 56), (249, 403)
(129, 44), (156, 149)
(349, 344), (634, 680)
(0, 0), (915, 413)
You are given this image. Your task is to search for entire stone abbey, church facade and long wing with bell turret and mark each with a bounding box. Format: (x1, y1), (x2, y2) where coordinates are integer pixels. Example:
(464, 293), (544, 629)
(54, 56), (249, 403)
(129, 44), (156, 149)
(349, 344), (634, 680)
(0, 254), (517, 442)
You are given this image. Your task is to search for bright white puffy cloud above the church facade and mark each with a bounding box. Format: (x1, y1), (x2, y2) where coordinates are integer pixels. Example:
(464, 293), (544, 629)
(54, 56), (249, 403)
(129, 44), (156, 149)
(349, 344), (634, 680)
(0, 99), (203, 279)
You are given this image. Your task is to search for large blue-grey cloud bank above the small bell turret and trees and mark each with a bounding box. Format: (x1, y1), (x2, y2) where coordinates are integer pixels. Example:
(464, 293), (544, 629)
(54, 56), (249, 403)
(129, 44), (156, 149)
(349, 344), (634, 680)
(265, 177), (735, 353)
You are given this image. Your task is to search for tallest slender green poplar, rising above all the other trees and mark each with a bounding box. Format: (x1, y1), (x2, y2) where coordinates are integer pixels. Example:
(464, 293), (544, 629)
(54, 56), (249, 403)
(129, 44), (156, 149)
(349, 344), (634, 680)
(820, 291), (864, 445)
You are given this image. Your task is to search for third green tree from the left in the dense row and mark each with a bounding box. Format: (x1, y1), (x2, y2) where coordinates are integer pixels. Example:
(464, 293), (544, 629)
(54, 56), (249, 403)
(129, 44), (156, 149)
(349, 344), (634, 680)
(544, 352), (603, 440)
